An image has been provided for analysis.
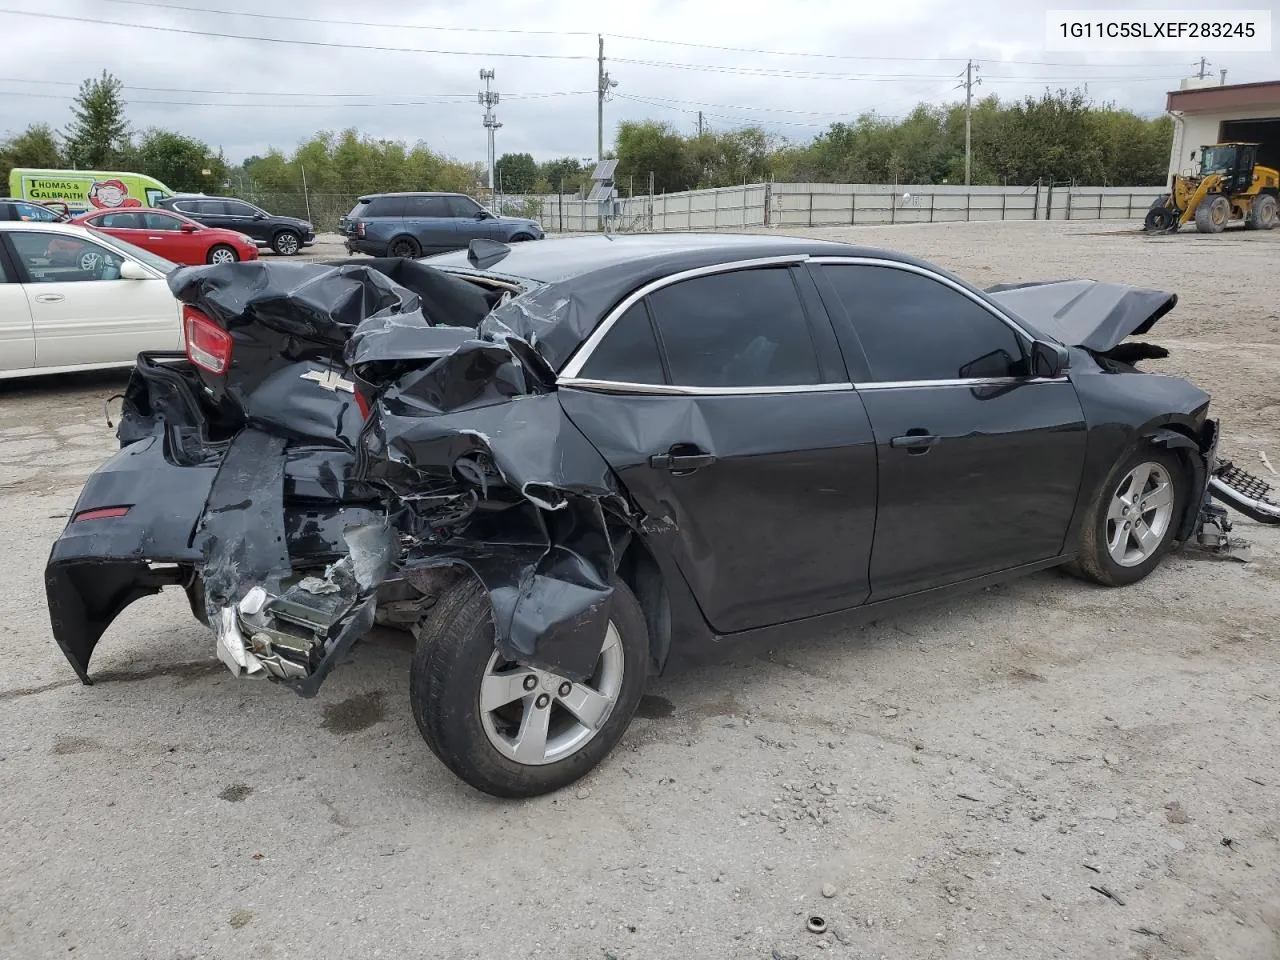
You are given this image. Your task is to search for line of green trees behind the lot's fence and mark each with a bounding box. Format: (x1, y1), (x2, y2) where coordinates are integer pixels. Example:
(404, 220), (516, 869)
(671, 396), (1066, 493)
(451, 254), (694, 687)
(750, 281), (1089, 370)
(0, 72), (1172, 204)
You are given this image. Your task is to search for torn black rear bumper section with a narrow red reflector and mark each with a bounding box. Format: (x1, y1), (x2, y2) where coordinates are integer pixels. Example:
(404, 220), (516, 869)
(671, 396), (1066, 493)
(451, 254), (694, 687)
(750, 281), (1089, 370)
(45, 435), (218, 684)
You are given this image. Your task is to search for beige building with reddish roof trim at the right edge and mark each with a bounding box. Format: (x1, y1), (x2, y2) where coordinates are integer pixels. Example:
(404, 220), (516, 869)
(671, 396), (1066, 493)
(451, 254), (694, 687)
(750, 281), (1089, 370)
(1166, 79), (1280, 185)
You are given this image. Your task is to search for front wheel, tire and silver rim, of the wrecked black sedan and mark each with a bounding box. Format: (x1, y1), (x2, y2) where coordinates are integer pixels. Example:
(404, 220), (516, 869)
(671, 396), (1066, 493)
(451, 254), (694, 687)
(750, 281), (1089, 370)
(1075, 447), (1189, 586)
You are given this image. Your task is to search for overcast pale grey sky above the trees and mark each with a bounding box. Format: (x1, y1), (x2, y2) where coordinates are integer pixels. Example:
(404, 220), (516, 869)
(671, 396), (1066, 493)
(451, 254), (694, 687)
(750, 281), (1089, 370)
(0, 0), (1280, 163)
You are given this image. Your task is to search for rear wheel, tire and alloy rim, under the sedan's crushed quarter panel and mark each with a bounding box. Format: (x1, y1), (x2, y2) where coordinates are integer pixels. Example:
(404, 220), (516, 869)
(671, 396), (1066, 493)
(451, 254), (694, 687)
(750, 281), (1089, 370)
(410, 577), (649, 797)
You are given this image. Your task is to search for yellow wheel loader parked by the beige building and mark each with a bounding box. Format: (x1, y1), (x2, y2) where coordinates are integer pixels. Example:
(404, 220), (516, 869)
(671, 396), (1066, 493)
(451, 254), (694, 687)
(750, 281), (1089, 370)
(1143, 143), (1280, 233)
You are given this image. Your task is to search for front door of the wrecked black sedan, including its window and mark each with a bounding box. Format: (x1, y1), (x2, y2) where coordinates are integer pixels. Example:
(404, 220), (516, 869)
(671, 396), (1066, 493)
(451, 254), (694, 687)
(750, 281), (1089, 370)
(814, 260), (1087, 600)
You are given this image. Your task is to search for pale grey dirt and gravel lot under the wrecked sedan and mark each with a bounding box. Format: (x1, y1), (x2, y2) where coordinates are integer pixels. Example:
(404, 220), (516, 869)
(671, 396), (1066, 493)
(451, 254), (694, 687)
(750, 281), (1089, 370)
(0, 223), (1280, 960)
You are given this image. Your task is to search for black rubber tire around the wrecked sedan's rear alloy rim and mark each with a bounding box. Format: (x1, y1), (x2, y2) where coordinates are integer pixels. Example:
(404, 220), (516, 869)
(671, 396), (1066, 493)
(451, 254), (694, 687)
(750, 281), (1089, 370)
(410, 577), (649, 797)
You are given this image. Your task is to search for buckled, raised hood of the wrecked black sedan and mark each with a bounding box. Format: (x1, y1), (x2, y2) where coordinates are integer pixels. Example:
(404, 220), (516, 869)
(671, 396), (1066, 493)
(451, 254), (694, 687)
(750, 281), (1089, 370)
(986, 280), (1178, 353)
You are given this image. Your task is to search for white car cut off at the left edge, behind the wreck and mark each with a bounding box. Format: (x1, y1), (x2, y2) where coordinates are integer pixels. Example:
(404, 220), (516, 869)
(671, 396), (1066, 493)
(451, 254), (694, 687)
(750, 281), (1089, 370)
(0, 220), (182, 379)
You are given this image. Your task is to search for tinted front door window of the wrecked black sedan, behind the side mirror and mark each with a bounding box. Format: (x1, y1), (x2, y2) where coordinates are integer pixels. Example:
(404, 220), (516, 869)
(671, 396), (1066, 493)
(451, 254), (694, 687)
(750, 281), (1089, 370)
(823, 265), (1025, 383)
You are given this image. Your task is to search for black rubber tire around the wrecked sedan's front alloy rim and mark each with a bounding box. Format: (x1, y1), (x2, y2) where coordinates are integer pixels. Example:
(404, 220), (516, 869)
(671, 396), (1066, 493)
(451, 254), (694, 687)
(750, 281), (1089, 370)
(1071, 445), (1190, 586)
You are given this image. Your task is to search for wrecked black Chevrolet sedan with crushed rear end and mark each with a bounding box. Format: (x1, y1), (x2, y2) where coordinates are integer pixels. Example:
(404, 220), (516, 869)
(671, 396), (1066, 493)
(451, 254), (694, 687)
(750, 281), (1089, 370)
(46, 236), (1280, 796)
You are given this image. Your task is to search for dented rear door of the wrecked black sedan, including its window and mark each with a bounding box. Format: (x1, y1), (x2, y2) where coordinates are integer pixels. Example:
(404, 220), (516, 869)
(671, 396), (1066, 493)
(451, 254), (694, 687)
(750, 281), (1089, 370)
(559, 259), (876, 634)
